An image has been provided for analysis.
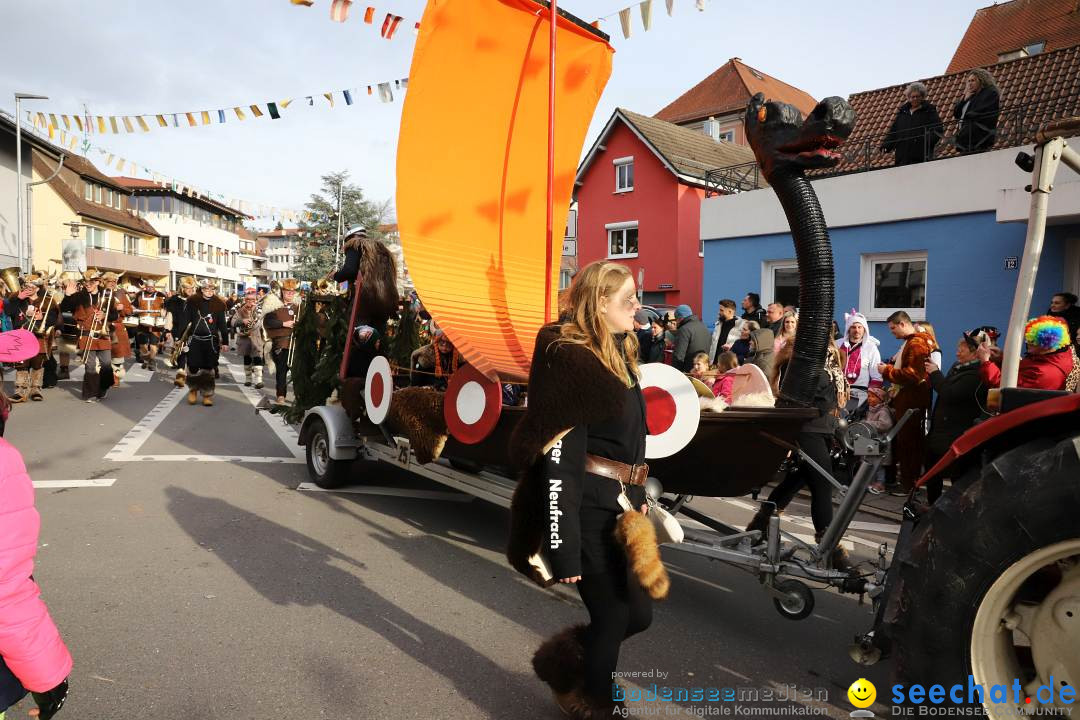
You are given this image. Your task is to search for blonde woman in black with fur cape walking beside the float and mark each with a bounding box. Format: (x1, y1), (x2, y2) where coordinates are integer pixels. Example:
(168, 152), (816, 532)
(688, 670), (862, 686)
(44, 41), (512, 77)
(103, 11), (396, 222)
(507, 261), (667, 720)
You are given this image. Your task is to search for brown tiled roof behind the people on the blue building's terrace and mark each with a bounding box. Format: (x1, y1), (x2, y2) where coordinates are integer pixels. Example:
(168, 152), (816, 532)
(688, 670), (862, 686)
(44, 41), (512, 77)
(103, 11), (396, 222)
(814, 45), (1080, 175)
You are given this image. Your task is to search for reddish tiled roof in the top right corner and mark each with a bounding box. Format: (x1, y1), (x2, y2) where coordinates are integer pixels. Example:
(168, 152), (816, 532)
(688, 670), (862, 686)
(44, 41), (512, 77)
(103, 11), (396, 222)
(945, 0), (1080, 72)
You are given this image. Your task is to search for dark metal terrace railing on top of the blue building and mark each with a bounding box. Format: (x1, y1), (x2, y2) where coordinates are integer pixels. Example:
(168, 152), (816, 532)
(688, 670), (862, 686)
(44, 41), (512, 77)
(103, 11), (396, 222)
(705, 93), (1080, 198)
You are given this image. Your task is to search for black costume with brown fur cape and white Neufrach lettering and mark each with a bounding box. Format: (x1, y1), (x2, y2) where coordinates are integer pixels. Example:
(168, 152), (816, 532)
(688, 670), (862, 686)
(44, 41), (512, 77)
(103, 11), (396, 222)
(507, 325), (666, 708)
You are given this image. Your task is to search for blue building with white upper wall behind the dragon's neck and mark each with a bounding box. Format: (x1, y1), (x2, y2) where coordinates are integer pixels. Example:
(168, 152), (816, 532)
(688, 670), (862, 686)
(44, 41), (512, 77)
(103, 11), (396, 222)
(701, 141), (1080, 368)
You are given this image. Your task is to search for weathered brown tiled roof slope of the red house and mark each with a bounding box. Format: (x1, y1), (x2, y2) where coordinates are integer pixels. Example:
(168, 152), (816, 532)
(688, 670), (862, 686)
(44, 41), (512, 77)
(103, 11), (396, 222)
(616, 108), (754, 181)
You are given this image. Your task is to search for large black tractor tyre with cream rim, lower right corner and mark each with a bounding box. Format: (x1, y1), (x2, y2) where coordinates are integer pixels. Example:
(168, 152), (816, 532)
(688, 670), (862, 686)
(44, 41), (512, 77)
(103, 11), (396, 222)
(893, 437), (1080, 718)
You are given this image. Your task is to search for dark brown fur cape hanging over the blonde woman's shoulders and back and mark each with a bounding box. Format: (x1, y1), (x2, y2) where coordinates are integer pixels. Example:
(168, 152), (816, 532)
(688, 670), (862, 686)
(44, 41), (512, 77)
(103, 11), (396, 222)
(507, 325), (626, 580)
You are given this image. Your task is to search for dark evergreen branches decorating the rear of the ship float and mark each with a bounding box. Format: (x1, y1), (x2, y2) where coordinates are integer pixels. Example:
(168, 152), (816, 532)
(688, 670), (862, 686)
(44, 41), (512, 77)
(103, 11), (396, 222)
(274, 296), (349, 423)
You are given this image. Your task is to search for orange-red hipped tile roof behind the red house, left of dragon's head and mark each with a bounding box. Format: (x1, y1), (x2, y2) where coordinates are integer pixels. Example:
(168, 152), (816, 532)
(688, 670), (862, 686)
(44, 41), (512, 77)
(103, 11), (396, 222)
(654, 57), (818, 123)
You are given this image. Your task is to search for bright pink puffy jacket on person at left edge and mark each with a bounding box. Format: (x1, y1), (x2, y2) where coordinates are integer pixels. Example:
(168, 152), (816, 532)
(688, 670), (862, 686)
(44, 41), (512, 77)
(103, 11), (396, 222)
(0, 438), (71, 692)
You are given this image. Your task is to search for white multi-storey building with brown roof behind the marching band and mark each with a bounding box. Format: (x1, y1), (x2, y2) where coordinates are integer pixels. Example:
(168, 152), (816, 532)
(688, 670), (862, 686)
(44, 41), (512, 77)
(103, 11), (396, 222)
(112, 177), (248, 295)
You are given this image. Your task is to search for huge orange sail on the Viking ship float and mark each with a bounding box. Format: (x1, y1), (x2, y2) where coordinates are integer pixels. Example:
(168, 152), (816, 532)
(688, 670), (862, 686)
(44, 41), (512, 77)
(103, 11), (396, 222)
(396, 0), (613, 380)
